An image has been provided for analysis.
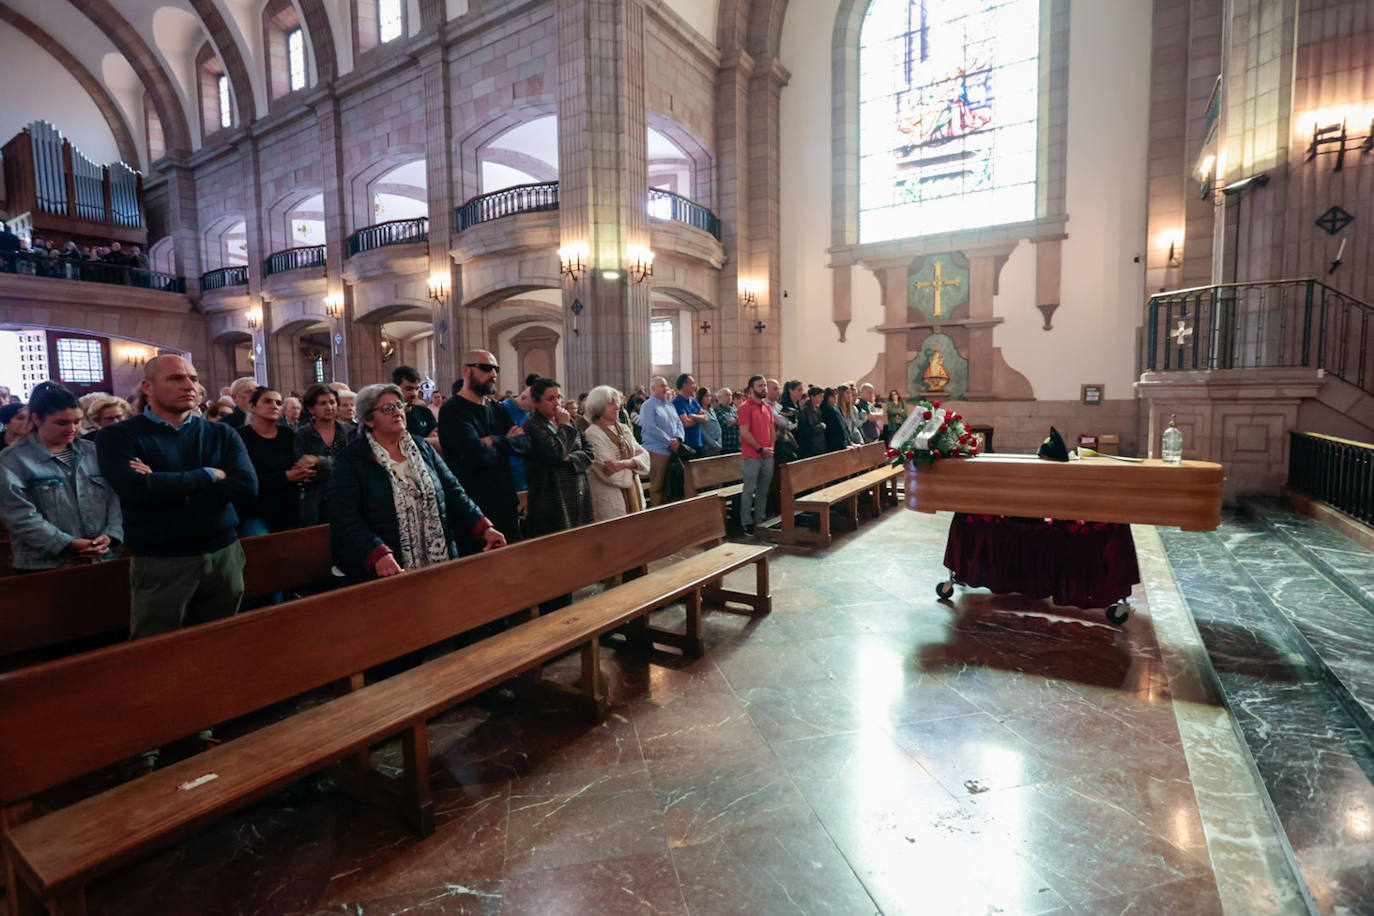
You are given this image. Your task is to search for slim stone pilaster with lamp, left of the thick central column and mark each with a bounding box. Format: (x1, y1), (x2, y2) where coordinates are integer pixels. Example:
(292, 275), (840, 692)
(419, 45), (461, 396)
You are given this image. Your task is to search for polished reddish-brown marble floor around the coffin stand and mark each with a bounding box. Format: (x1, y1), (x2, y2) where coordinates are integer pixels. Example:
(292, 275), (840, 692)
(72, 511), (1319, 916)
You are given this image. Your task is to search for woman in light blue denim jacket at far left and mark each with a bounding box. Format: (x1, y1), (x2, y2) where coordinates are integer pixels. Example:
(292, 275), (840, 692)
(0, 382), (124, 571)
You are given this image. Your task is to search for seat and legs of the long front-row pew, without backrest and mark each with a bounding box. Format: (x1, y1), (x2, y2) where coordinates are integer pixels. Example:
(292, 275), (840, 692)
(3, 544), (772, 913)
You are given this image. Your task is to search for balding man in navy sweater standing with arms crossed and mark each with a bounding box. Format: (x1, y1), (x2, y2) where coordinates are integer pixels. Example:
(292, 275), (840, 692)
(95, 356), (257, 639)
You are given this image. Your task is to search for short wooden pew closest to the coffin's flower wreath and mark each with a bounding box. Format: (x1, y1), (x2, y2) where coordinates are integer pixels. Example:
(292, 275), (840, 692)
(779, 442), (904, 547)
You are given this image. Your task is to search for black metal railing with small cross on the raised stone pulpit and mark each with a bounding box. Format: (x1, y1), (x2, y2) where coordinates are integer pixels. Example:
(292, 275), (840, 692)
(1145, 277), (1374, 391)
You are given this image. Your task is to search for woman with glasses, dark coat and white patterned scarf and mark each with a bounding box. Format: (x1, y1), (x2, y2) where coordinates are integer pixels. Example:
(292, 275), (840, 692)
(328, 385), (506, 581)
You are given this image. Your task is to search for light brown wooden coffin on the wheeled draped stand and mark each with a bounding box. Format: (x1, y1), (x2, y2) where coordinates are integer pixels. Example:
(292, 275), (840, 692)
(907, 455), (1223, 531)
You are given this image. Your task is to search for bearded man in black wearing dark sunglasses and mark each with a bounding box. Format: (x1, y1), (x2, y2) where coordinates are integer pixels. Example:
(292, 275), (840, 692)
(438, 350), (529, 555)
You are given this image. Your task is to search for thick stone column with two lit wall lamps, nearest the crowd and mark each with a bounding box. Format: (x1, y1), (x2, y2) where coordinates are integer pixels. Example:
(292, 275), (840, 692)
(556, 0), (650, 393)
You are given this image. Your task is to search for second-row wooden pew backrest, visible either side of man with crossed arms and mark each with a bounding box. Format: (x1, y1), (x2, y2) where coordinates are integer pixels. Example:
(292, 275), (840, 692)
(0, 525), (333, 667)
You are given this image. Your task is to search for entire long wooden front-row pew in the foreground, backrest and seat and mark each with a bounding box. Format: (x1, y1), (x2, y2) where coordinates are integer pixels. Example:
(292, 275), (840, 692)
(0, 497), (771, 913)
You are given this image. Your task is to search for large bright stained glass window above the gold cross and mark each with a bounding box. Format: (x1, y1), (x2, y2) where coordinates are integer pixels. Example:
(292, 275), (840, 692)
(859, 0), (1040, 242)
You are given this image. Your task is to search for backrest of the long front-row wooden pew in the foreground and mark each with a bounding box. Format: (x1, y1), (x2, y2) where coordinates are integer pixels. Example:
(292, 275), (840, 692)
(0, 496), (724, 805)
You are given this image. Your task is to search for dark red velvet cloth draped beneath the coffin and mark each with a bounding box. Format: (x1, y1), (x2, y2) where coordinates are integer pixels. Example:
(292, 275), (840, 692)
(945, 514), (1140, 607)
